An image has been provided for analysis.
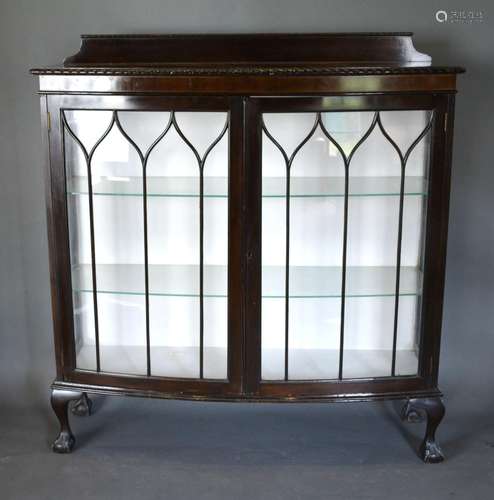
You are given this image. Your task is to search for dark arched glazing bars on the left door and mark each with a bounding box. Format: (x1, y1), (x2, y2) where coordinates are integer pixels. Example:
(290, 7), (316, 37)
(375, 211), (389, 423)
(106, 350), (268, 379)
(62, 110), (229, 379)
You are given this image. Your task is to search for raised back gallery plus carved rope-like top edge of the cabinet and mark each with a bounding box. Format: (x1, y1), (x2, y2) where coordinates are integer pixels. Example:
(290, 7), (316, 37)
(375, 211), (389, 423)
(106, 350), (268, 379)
(31, 33), (464, 76)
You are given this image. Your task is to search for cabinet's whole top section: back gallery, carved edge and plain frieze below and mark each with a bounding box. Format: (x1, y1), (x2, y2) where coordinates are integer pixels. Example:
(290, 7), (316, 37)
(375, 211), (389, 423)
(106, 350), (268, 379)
(31, 33), (464, 95)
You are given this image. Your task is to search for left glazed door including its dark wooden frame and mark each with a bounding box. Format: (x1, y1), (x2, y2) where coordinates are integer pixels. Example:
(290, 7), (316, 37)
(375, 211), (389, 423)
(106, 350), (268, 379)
(49, 96), (242, 395)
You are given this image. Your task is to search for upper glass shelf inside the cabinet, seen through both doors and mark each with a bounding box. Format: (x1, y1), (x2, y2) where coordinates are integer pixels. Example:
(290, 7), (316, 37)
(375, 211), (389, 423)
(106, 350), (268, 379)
(68, 176), (427, 198)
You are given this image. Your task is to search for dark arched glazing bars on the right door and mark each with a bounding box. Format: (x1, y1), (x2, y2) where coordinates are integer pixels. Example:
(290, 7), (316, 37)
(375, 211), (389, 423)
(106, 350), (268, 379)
(261, 111), (434, 381)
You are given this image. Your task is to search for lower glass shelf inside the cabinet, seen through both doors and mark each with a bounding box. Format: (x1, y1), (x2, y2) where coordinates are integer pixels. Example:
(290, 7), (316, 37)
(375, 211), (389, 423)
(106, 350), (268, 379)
(72, 264), (422, 299)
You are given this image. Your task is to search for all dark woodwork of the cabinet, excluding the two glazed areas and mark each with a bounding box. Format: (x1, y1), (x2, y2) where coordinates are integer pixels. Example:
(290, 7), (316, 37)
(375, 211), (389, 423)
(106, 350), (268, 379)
(32, 33), (463, 462)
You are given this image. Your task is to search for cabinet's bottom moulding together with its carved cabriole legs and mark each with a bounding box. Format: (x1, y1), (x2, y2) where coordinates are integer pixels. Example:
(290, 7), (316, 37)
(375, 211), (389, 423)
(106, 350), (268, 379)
(51, 381), (445, 463)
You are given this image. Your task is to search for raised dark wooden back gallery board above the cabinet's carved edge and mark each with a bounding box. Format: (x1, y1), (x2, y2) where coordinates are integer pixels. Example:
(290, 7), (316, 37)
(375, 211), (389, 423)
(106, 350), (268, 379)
(60, 33), (431, 67)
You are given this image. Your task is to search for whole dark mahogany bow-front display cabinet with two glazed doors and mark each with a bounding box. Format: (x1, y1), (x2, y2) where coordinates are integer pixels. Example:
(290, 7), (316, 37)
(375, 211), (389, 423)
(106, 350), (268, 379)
(32, 33), (463, 462)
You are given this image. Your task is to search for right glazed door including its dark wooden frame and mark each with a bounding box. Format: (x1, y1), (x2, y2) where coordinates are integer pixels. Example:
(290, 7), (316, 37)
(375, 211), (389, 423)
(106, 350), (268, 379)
(247, 96), (447, 397)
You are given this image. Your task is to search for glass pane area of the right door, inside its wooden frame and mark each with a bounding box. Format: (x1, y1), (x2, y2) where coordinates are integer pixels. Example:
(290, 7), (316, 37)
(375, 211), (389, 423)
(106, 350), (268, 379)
(261, 111), (432, 380)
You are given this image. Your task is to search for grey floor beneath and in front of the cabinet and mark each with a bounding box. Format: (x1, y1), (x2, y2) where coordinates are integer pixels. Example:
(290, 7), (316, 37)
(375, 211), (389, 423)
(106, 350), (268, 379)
(0, 376), (494, 500)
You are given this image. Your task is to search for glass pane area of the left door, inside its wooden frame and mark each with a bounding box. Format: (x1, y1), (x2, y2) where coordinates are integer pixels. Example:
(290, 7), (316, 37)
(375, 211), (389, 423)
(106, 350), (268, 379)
(62, 110), (228, 380)
